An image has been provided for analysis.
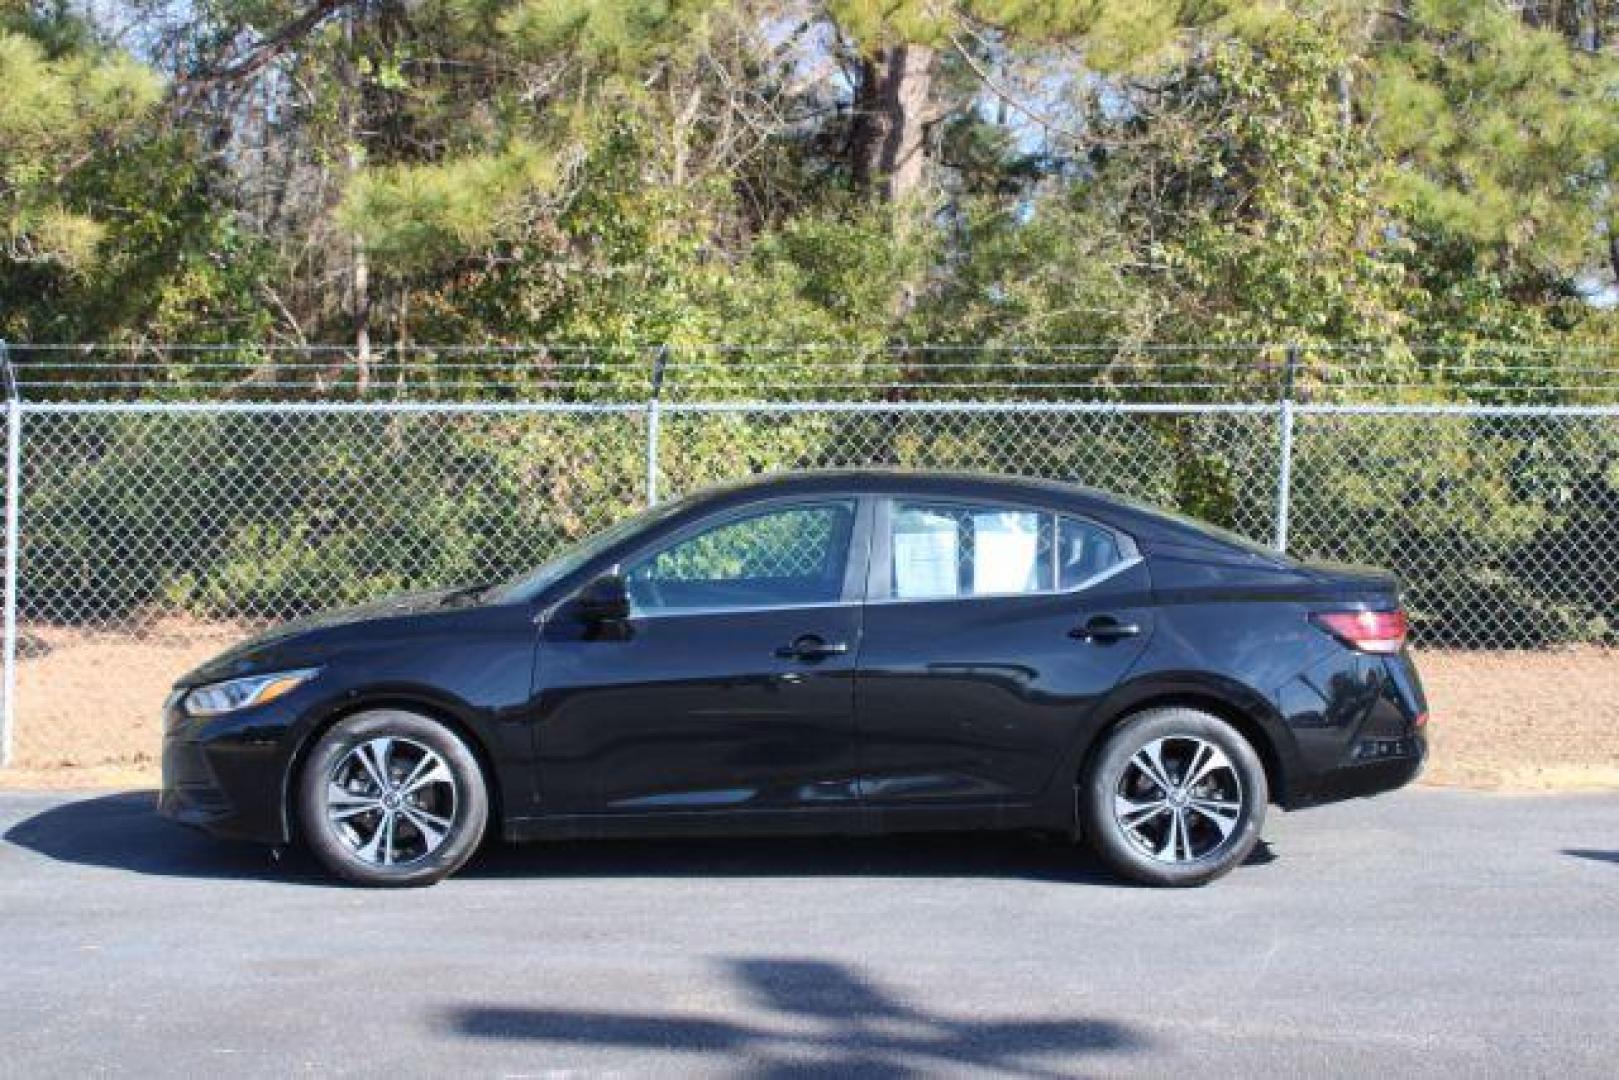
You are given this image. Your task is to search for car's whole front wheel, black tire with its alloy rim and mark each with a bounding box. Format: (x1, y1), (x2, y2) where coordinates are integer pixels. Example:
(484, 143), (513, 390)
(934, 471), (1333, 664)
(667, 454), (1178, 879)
(296, 709), (489, 886)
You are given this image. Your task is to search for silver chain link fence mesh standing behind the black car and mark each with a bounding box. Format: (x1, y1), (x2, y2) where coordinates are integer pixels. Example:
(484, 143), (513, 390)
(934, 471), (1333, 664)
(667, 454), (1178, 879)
(5, 341), (1619, 764)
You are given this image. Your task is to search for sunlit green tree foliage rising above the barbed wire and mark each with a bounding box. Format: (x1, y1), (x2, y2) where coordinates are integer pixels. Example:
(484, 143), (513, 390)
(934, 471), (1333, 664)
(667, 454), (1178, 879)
(9, 0), (1619, 354)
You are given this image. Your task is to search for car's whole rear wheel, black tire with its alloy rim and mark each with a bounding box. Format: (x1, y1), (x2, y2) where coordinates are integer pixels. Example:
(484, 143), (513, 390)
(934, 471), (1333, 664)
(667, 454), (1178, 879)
(1078, 708), (1269, 886)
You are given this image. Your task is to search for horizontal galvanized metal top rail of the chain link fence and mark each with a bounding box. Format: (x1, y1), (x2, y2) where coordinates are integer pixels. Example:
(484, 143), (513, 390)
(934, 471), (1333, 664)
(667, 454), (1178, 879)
(16, 398), (1619, 419)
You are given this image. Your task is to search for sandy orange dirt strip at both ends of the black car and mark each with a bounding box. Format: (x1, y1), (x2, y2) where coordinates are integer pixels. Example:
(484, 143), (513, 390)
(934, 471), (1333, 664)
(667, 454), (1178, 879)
(0, 622), (1619, 792)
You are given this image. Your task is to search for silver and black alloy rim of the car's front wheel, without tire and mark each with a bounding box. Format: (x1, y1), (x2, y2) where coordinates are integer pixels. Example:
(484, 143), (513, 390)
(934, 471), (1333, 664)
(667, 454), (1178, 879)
(325, 735), (457, 866)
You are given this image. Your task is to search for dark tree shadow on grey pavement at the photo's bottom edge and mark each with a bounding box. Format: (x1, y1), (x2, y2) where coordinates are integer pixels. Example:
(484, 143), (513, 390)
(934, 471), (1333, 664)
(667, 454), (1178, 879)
(445, 959), (1148, 1077)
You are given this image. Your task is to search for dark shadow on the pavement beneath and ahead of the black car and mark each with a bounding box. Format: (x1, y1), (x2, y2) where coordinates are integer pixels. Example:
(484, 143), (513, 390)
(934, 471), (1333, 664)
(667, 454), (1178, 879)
(5, 792), (1276, 889)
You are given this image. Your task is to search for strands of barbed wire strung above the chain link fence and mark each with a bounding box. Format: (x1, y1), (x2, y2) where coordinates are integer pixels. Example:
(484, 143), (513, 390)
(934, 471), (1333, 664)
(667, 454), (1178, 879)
(6, 342), (1619, 405)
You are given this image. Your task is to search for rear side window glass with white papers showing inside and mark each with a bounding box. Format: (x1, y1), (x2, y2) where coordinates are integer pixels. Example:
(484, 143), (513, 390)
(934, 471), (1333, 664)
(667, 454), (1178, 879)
(889, 502), (1122, 601)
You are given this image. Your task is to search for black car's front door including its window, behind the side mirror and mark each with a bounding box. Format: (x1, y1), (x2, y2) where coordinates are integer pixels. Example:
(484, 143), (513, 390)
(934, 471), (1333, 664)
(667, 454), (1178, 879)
(538, 499), (866, 816)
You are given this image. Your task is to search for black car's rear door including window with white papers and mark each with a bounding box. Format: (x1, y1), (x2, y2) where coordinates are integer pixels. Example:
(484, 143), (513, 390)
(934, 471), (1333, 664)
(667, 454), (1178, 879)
(855, 497), (1153, 810)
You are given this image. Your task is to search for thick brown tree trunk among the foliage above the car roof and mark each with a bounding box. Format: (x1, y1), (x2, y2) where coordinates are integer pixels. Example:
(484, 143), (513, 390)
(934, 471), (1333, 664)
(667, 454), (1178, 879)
(850, 45), (934, 202)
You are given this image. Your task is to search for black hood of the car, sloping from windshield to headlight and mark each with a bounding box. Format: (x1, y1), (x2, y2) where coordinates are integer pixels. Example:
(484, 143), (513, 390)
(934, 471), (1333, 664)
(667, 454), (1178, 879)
(175, 586), (482, 687)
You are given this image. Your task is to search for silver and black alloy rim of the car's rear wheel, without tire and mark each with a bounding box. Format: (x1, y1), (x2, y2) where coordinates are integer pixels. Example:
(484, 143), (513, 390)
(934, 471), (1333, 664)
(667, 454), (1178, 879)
(1114, 735), (1243, 863)
